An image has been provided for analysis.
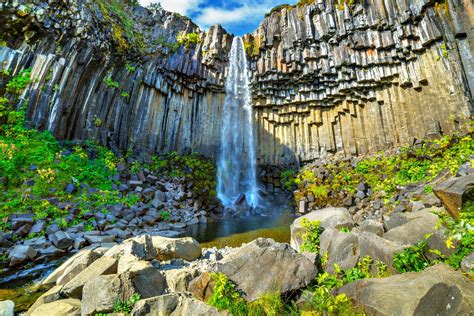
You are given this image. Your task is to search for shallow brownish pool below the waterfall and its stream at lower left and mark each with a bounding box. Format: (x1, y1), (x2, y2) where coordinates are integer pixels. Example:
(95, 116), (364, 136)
(0, 209), (294, 312)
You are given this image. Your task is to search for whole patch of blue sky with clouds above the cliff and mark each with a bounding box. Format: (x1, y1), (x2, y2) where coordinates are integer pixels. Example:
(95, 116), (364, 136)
(140, 0), (297, 35)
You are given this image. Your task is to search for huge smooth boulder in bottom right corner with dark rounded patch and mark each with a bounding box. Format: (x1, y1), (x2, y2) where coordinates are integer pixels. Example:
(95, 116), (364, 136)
(338, 264), (474, 316)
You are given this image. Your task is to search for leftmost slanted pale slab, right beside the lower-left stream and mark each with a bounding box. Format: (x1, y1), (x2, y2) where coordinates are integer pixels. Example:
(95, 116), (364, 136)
(41, 250), (102, 285)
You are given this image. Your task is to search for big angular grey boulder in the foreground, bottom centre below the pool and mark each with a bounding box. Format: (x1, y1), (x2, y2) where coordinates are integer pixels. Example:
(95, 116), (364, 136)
(216, 238), (318, 301)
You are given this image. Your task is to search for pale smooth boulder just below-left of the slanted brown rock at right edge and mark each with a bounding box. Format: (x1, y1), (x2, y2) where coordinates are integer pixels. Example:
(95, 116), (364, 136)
(384, 210), (438, 245)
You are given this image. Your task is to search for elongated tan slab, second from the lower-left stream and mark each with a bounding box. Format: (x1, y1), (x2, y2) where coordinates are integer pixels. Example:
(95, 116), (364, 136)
(61, 256), (117, 299)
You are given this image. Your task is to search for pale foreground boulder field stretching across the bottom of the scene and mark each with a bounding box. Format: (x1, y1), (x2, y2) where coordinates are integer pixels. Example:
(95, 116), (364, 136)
(2, 168), (474, 315)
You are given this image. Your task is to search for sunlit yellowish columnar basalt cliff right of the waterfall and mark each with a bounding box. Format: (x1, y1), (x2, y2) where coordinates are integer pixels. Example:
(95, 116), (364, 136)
(246, 0), (474, 164)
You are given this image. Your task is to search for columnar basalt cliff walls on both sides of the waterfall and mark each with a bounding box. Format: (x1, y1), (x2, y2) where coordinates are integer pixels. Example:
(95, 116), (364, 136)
(0, 0), (474, 165)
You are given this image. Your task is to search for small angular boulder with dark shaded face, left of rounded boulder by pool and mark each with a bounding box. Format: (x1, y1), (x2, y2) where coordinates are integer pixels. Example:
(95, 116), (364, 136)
(104, 235), (156, 260)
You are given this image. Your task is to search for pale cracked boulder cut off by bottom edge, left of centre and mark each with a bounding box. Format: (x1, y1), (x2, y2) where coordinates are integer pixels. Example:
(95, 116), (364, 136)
(132, 293), (221, 316)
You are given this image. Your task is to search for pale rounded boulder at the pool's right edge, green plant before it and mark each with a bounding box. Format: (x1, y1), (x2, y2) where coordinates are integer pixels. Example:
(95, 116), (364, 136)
(290, 207), (354, 251)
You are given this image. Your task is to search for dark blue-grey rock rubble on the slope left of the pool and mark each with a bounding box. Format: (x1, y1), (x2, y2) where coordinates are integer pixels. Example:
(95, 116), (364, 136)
(0, 166), (222, 267)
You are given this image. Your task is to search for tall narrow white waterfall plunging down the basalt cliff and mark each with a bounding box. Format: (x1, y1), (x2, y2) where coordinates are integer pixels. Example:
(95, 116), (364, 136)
(217, 37), (259, 207)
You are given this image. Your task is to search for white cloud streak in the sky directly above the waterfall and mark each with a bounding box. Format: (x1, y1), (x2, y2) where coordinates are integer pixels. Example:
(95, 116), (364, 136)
(195, 0), (281, 28)
